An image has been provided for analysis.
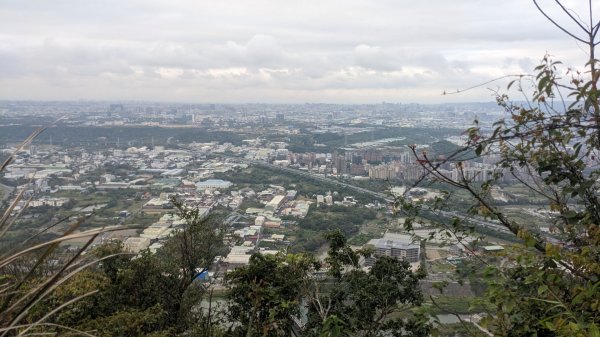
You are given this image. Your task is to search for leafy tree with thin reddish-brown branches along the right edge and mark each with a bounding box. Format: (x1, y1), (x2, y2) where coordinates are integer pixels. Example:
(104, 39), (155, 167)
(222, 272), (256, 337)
(397, 0), (600, 336)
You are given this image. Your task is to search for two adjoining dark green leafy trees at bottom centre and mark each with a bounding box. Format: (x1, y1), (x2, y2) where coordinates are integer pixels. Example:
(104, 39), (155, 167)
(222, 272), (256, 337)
(227, 230), (431, 337)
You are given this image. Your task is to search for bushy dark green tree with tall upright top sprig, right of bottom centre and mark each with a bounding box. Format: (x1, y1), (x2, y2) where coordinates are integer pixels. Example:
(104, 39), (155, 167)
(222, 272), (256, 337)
(305, 230), (431, 337)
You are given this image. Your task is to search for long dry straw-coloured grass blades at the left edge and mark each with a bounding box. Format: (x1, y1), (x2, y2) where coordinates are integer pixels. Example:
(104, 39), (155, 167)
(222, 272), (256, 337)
(0, 128), (135, 337)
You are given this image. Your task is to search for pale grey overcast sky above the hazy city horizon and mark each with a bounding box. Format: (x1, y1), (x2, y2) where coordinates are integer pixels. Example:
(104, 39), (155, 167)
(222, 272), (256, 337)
(0, 0), (600, 103)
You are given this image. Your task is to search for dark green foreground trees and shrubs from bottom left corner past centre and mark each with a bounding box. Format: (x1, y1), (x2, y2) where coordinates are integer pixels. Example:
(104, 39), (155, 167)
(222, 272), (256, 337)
(0, 205), (431, 337)
